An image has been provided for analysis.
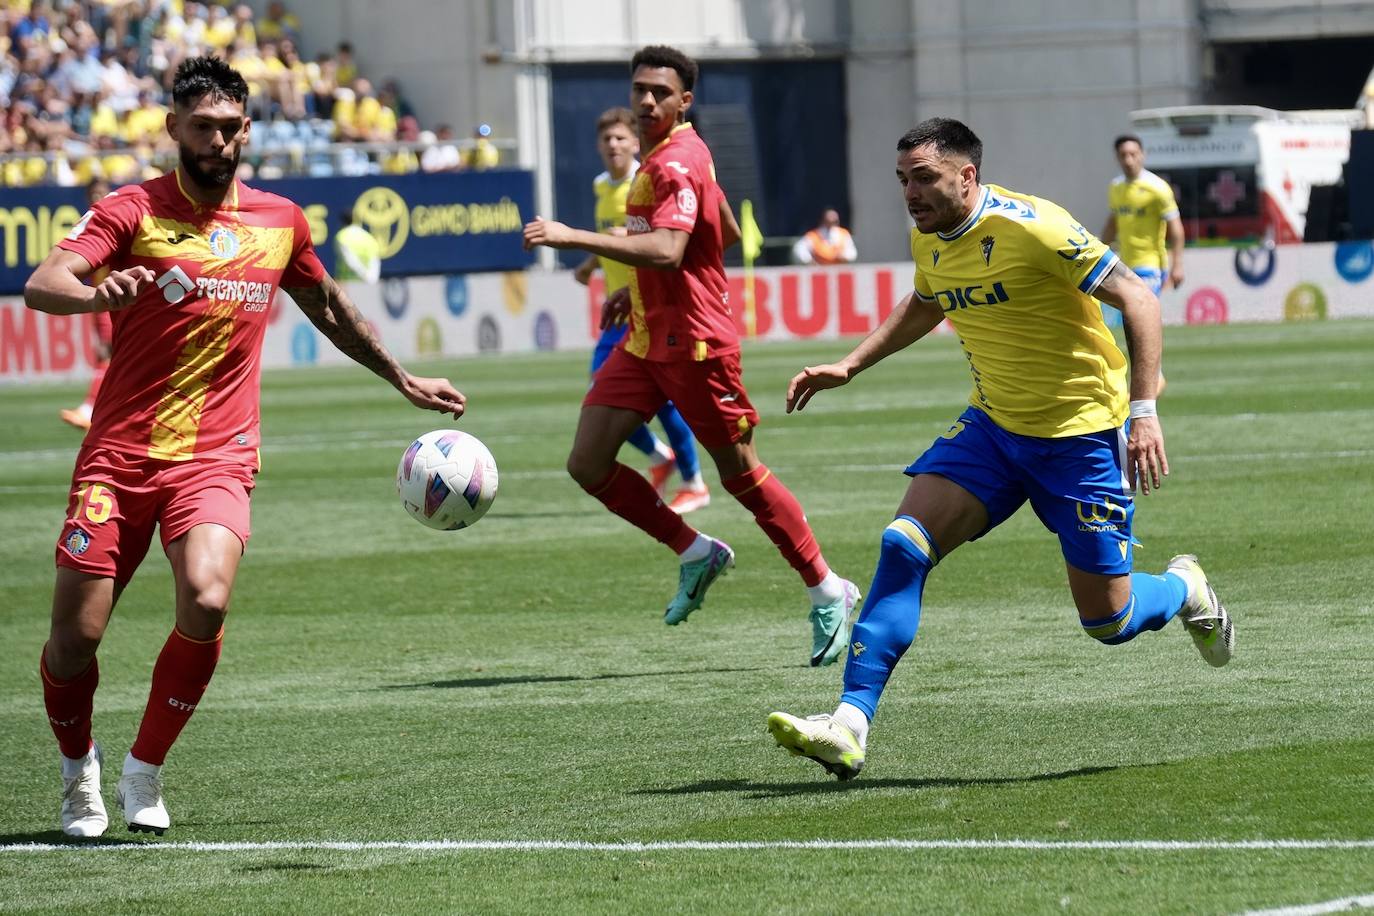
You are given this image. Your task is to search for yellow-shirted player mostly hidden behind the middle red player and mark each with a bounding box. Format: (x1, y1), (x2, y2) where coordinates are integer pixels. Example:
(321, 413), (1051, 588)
(573, 108), (710, 515)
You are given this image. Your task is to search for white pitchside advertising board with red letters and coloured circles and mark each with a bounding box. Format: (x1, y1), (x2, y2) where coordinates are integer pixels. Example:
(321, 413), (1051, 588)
(0, 242), (1374, 383)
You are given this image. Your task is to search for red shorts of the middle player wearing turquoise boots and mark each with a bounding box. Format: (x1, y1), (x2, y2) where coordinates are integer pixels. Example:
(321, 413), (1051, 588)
(583, 347), (758, 448)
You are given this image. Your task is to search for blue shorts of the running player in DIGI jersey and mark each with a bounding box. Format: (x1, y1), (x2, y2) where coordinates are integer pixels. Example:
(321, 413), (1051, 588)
(905, 407), (1135, 575)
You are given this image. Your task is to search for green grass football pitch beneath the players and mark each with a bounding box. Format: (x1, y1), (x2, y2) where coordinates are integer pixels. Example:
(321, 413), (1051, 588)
(0, 321), (1374, 915)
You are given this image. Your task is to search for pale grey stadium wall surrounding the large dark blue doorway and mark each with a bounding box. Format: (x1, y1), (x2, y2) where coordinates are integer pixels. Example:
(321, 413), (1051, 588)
(281, 0), (1201, 262)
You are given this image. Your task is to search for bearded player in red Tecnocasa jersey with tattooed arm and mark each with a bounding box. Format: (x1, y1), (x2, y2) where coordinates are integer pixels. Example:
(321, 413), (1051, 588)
(25, 58), (464, 836)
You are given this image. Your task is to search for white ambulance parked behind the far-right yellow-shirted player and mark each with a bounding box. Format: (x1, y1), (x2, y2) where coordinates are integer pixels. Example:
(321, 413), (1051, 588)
(1131, 104), (1364, 244)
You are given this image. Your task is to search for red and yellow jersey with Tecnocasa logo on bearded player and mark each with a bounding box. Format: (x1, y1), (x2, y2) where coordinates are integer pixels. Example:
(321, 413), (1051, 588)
(58, 169), (324, 467)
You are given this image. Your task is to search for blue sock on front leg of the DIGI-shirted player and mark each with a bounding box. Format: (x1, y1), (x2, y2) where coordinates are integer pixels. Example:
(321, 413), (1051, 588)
(840, 515), (940, 718)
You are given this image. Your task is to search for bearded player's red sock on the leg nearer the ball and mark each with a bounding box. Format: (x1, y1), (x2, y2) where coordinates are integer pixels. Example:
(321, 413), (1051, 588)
(129, 628), (224, 766)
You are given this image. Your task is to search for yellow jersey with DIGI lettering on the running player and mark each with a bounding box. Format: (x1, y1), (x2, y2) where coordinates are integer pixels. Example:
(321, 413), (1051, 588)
(911, 184), (1129, 438)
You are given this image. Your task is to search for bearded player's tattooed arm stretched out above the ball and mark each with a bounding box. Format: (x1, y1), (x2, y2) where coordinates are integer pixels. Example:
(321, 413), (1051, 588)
(284, 275), (467, 417)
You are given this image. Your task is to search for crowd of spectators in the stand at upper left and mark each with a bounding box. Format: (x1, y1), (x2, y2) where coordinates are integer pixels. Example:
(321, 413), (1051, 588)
(0, 0), (499, 187)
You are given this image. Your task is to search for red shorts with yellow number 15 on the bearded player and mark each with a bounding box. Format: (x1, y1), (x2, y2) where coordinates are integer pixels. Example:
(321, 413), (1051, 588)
(58, 446), (253, 582)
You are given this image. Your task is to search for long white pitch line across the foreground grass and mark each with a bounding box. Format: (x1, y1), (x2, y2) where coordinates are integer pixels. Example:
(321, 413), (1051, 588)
(0, 839), (1374, 856)
